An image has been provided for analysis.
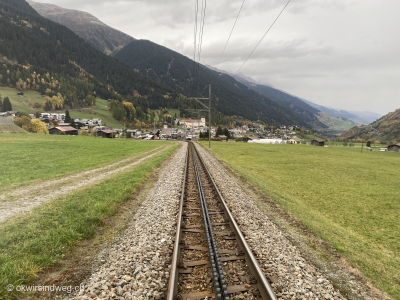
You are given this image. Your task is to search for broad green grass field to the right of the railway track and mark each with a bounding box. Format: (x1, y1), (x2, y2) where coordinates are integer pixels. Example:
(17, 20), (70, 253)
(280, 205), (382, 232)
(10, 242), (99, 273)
(204, 142), (400, 299)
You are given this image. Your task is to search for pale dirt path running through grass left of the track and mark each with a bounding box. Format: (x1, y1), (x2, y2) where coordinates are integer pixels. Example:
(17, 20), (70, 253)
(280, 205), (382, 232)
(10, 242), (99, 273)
(0, 146), (168, 223)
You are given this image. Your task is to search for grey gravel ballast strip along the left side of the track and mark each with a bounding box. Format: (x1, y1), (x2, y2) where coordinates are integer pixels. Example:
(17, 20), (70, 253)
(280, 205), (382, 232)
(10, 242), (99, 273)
(74, 143), (187, 299)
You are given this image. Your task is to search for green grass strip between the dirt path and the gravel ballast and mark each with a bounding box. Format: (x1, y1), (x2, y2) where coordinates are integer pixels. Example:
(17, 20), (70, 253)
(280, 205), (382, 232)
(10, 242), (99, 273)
(0, 144), (178, 299)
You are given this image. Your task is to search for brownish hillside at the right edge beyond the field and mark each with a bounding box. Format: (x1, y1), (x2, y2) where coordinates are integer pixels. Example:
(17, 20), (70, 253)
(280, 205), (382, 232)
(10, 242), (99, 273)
(341, 109), (400, 143)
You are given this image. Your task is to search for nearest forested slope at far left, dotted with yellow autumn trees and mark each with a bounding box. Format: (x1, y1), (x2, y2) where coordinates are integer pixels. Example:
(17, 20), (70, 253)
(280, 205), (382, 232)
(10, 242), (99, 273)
(0, 0), (176, 117)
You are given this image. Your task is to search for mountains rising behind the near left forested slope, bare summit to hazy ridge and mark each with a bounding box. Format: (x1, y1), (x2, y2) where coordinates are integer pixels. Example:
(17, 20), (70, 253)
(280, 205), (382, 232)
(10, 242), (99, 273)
(22, 1), (381, 135)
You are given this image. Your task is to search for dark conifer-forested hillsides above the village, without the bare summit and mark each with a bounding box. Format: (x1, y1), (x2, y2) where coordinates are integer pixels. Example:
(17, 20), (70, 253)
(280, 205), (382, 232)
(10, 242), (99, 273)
(0, 0), (308, 127)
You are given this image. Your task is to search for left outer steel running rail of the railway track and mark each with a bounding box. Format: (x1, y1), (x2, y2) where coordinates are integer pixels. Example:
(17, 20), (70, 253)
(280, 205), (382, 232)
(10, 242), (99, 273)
(167, 149), (189, 300)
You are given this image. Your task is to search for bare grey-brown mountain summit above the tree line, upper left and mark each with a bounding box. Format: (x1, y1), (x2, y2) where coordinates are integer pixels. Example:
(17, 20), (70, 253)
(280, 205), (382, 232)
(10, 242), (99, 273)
(28, 1), (134, 55)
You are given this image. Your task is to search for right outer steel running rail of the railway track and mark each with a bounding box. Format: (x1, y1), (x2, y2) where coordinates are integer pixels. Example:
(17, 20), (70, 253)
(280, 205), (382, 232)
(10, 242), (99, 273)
(195, 143), (277, 300)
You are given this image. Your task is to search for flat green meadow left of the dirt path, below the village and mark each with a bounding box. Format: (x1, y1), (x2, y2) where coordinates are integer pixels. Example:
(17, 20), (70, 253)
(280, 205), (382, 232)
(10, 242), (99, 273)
(0, 134), (168, 190)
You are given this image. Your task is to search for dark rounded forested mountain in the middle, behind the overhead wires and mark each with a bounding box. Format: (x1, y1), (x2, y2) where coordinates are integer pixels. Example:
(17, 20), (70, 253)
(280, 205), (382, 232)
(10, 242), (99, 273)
(115, 40), (309, 127)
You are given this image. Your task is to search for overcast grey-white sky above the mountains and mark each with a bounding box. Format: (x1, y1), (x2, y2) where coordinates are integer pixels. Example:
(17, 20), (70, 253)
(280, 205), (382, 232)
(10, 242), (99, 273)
(35, 0), (400, 114)
